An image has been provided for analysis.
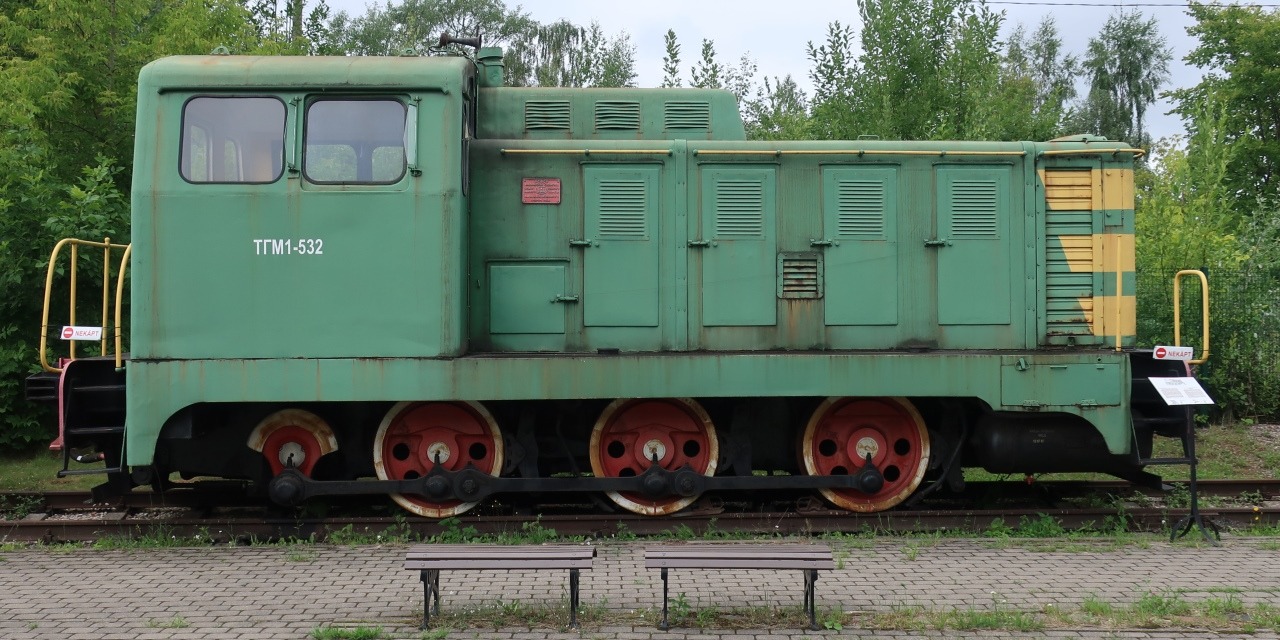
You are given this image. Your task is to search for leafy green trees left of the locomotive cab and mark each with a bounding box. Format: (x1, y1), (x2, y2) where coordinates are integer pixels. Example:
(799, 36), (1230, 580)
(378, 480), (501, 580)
(0, 0), (248, 447)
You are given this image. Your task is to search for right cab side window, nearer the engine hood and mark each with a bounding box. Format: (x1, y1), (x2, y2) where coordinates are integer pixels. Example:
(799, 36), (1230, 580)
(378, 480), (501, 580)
(302, 99), (407, 184)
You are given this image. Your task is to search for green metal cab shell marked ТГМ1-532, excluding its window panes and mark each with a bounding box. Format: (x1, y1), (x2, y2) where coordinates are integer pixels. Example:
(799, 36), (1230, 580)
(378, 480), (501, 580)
(131, 56), (467, 360)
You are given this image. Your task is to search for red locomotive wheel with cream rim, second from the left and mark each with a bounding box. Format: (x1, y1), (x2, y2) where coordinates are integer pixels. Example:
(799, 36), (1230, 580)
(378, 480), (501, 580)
(374, 402), (503, 518)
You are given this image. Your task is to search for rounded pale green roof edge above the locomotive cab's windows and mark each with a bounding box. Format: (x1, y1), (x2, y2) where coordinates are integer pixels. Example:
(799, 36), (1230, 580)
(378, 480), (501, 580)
(138, 55), (472, 92)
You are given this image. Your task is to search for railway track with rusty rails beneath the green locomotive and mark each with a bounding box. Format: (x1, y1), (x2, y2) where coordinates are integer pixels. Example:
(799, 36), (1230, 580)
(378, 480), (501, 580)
(0, 480), (1280, 544)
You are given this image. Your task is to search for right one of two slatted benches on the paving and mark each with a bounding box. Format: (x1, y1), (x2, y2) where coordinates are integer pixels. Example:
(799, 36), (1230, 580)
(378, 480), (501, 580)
(644, 543), (836, 630)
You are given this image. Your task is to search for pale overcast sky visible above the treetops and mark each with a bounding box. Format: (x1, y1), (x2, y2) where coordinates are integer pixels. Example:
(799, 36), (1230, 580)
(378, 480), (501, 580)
(326, 0), (1199, 138)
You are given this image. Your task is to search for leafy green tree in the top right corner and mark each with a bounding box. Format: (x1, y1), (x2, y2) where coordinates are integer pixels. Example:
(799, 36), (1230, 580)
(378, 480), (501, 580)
(1171, 4), (1280, 215)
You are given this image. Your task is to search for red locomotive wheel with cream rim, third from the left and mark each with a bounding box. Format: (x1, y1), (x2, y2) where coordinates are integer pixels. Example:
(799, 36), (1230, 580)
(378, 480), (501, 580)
(589, 398), (719, 516)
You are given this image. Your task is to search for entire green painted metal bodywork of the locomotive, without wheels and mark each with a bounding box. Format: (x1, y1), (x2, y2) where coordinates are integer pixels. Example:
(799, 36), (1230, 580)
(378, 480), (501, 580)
(120, 56), (1133, 465)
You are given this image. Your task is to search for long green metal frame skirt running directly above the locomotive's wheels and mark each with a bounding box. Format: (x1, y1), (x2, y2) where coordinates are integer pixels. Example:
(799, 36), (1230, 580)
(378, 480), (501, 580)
(127, 352), (1132, 465)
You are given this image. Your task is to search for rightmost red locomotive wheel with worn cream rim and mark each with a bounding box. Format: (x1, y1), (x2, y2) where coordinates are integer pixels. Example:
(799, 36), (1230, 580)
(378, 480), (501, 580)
(800, 397), (929, 512)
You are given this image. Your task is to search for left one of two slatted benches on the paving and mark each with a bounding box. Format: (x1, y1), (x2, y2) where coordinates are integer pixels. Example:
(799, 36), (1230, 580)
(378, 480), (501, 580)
(404, 544), (595, 628)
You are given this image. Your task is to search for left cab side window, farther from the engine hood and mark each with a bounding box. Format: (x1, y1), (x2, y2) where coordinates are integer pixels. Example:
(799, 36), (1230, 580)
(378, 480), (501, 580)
(179, 96), (284, 184)
